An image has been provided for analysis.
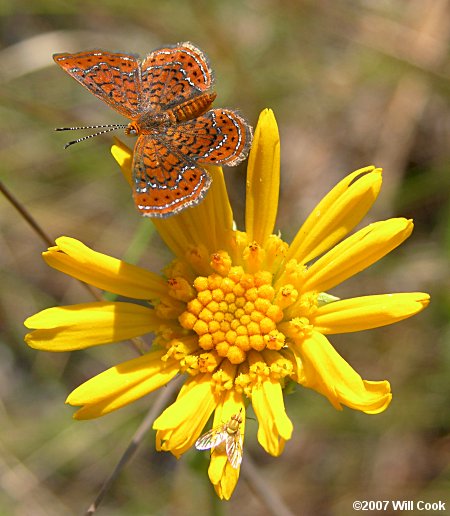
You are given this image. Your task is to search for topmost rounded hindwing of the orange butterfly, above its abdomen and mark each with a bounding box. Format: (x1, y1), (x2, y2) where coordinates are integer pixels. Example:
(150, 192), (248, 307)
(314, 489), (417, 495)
(141, 43), (213, 112)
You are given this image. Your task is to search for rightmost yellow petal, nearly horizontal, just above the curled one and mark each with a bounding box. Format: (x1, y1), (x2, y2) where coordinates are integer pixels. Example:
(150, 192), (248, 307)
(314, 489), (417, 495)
(311, 292), (430, 334)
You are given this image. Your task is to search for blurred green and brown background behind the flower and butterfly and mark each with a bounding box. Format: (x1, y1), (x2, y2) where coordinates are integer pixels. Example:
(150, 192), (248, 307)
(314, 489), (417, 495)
(0, 0), (450, 516)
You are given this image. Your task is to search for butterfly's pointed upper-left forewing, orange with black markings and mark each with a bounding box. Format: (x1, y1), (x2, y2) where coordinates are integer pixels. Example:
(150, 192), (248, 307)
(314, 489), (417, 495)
(53, 50), (142, 118)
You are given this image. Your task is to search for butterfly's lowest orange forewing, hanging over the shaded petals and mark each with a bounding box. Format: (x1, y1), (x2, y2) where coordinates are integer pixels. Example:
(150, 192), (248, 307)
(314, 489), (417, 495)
(133, 135), (211, 218)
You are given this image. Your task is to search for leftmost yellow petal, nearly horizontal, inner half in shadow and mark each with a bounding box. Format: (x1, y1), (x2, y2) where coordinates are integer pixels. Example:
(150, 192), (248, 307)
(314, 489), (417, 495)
(24, 302), (161, 351)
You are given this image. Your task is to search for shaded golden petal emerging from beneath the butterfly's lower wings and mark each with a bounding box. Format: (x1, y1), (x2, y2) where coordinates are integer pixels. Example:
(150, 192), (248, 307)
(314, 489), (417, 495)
(153, 166), (233, 258)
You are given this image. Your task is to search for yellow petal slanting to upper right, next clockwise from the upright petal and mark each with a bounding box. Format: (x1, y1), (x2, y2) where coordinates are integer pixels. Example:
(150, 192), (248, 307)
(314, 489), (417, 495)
(286, 166), (382, 263)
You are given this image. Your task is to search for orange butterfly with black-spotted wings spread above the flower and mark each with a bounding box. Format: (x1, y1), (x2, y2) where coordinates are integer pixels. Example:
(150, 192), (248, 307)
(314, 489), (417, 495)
(53, 42), (252, 217)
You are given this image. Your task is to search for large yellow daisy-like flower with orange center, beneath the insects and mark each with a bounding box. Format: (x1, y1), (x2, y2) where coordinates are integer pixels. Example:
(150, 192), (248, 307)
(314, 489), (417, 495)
(25, 110), (429, 499)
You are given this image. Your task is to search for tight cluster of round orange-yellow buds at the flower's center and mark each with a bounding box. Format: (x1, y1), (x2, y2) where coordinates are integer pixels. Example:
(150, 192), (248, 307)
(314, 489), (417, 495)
(179, 266), (285, 364)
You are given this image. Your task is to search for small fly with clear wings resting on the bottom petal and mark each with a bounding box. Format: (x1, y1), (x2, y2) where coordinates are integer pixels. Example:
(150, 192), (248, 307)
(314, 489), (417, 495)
(195, 412), (243, 469)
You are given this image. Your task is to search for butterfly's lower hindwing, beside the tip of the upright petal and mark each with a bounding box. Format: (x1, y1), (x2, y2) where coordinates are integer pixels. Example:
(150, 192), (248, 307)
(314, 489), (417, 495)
(165, 109), (252, 166)
